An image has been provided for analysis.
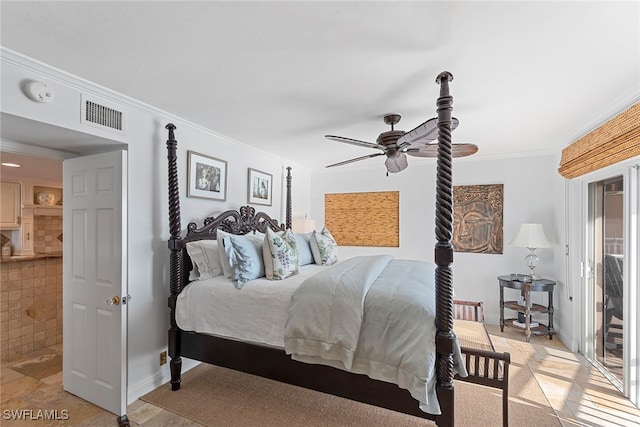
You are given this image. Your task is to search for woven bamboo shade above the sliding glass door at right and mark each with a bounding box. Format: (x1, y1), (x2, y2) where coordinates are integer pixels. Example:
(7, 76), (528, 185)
(558, 103), (640, 178)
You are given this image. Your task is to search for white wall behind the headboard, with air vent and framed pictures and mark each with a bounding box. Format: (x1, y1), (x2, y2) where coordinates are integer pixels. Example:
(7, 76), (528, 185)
(1, 51), (310, 402)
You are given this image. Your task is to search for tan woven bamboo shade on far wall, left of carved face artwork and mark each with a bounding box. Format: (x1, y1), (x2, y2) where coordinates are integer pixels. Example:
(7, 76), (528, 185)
(324, 191), (400, 247)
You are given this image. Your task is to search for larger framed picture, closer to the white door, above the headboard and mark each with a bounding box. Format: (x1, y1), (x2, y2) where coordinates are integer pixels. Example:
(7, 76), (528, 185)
(187, 151), (227, 201)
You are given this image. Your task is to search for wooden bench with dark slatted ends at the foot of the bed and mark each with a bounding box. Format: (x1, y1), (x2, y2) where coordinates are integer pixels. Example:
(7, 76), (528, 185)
(453, 300), (511, 427)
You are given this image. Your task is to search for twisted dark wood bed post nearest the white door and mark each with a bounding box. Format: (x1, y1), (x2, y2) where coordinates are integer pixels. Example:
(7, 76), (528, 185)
(165, 123), (182, 390)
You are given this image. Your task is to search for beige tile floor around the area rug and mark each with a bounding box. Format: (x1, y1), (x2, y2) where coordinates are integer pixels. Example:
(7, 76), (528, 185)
(0, 325), (640, 427)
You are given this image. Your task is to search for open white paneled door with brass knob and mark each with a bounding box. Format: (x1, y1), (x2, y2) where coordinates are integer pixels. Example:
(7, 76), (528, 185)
(63, 151), (127, 416)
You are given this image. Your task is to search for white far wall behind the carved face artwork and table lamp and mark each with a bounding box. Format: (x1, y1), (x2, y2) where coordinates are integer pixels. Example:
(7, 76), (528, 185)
(311, 155), (572, 331)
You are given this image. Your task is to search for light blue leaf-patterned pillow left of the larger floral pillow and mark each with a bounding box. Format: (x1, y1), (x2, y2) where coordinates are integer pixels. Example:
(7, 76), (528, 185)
(224, 234), (264, 289)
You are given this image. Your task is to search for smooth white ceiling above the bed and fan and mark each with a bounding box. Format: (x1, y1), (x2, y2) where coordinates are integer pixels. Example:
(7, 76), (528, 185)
(1, 1), (640, 170)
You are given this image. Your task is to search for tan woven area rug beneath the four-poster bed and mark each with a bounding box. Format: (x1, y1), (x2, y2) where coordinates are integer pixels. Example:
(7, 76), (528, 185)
(140, 355), (560, 427)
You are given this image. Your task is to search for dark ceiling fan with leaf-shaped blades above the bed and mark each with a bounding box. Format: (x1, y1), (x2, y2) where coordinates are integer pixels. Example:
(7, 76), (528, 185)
(325, 113), (478, 173)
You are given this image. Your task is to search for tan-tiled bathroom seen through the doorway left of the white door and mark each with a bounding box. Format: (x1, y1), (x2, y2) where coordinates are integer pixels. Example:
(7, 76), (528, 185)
(0, 151), (62, 362)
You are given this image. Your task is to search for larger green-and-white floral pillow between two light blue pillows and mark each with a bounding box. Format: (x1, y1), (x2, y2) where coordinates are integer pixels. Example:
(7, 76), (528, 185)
(262, 229), (300, 280)
